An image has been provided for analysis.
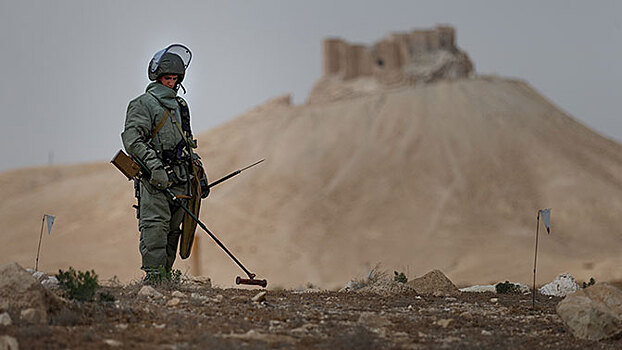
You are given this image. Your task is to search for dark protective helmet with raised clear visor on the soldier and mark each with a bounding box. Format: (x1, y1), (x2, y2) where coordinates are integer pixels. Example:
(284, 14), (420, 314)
(147, 44), (192, 84)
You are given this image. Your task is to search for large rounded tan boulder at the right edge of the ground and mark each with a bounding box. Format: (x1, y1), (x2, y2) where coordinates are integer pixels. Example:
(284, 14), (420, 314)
(557, 282), (622, 340)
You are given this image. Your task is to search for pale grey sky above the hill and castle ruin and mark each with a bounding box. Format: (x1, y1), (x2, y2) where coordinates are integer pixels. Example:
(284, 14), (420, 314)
(0, 0), (622, 171)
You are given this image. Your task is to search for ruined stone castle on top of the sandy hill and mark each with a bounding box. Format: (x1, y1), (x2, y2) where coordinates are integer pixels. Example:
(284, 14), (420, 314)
(308, 26), (474, 103)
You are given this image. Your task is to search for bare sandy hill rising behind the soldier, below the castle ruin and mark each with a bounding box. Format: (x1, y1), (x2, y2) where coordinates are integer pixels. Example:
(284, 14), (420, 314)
(0, 77), (622, 288)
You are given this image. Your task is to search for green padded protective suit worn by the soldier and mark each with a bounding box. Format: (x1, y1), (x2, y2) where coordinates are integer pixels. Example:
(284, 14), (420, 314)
(121, 82), (190, 274)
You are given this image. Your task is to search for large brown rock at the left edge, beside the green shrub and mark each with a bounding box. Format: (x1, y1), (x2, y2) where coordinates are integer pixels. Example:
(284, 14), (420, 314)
(0, 263), (63, 313)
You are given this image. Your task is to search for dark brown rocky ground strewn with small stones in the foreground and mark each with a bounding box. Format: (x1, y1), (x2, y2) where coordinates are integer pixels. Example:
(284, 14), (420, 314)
(0, 281), (622, 349)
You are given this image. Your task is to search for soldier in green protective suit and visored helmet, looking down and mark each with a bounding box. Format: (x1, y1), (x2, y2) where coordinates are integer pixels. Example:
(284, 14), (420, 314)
(121, 44), (209, 281)
